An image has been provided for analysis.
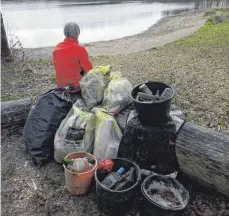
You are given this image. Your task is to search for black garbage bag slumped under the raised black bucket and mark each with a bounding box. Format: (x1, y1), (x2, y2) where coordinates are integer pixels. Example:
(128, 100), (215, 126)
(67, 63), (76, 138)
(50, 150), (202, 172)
(118, 107), (185, 173)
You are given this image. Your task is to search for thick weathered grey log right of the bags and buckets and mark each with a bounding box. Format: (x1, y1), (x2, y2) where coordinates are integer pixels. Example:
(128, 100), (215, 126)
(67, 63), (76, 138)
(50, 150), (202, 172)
(176, 123), (229, 196)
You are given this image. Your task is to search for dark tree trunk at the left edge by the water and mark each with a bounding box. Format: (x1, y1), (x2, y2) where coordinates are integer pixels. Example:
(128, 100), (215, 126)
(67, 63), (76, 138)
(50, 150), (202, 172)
(1, 13), (12, 60)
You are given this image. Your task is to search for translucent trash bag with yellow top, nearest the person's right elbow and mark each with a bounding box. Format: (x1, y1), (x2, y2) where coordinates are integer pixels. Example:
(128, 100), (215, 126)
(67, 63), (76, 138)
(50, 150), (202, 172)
(80, 66), (111, 109)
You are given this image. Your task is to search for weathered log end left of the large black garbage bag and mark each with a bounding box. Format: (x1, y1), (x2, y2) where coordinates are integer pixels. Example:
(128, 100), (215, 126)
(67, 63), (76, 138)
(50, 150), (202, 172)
(1, 98), (32, 127)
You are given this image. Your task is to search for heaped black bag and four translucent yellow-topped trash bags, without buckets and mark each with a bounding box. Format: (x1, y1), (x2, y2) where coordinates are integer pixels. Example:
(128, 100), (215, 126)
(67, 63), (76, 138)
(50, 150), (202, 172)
(23, 65), (132, 166)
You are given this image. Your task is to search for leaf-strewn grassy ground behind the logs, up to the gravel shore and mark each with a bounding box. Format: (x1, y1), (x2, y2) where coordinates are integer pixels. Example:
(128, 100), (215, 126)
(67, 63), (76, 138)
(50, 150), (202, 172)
(2, 10), (229, 134)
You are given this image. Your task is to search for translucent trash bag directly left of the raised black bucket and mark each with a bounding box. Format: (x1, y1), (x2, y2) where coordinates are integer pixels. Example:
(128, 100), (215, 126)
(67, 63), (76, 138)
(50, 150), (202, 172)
(102, 74), (132, 114)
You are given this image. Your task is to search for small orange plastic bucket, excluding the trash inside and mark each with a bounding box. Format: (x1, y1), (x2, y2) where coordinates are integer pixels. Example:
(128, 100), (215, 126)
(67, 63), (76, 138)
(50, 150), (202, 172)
(63, 152), (97, 195)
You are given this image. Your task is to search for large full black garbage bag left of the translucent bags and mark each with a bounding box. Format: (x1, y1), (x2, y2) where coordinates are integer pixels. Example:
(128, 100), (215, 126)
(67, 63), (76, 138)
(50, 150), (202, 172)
(23, 89), (79, 166)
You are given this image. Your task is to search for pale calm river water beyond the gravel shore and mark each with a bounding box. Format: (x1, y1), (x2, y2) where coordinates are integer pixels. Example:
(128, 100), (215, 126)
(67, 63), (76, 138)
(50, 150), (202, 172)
(2, 0), (229, 48)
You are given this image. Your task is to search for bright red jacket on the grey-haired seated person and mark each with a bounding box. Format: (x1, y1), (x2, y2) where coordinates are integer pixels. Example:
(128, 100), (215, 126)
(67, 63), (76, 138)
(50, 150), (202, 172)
(53, 38), (92, 88)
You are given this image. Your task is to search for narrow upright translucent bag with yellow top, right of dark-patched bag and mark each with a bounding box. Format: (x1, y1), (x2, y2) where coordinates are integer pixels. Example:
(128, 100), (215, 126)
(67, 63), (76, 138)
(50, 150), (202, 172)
(93, 109), (122, 161)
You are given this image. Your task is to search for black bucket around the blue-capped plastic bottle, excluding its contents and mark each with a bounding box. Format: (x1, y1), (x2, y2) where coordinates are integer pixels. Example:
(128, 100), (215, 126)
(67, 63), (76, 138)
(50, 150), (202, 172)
(95, 158), (141, 215)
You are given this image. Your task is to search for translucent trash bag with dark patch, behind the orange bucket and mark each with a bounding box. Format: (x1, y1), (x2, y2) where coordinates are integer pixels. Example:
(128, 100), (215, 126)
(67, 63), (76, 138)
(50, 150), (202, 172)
(54, 100), (96, 163)
